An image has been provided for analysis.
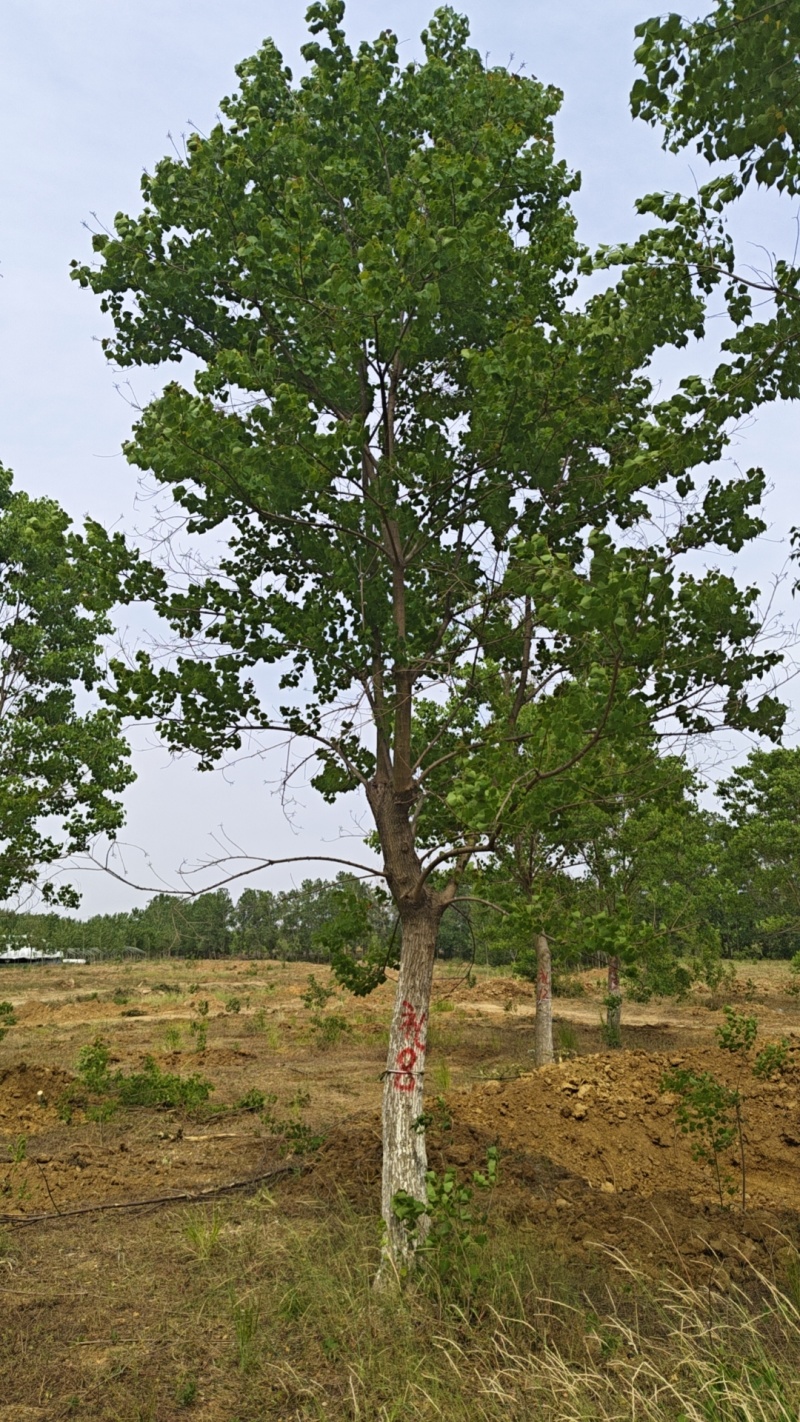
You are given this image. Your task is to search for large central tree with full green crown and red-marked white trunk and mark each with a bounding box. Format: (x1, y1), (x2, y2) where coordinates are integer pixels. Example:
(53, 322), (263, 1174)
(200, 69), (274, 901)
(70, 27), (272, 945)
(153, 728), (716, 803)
(74, 0), (779, 1277)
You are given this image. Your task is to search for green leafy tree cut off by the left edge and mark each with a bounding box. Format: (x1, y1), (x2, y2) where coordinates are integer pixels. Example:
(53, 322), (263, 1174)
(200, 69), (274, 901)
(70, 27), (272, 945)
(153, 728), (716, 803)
(0, 466), (134, 904)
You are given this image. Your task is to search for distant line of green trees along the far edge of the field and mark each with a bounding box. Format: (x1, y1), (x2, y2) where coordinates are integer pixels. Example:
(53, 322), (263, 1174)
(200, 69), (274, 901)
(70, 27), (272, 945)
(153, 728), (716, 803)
(6, 748), (800, 972)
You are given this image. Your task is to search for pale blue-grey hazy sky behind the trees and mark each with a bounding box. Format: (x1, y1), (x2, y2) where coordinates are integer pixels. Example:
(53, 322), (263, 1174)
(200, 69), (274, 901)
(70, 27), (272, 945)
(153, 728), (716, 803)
(0, 0), (800, 913)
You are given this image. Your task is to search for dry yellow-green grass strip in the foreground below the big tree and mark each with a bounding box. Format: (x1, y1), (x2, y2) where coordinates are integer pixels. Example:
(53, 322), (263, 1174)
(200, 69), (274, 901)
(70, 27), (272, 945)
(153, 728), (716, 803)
(0, 1185), (800, 1422)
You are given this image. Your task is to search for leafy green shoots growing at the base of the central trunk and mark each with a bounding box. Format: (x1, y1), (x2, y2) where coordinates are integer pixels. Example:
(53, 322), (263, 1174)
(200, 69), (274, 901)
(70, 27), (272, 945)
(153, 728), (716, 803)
(392, 1146), (499, 1294)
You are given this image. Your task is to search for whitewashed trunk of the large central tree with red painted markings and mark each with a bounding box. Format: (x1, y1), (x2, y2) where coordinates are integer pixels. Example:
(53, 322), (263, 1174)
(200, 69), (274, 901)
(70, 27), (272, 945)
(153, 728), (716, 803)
(375, 902), (440, 1287)
